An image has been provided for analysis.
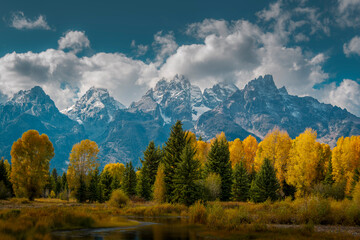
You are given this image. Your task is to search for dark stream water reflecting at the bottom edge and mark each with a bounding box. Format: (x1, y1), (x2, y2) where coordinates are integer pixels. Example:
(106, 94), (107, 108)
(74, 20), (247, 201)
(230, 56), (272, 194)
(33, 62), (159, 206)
(52, 222), (204, 240)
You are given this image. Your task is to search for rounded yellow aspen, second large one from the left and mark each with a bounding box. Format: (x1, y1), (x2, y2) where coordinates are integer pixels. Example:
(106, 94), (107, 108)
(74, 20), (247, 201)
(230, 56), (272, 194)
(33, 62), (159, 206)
(67, 139), (99, 190)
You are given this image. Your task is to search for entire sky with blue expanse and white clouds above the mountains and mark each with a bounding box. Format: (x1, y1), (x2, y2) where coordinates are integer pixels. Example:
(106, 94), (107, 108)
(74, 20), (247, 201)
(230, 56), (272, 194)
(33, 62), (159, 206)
(0, 0), (360, 115)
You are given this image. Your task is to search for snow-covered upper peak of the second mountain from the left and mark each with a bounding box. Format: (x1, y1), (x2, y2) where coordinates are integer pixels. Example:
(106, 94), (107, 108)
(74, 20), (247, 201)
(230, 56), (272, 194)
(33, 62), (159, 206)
(62, 87), (125, 123)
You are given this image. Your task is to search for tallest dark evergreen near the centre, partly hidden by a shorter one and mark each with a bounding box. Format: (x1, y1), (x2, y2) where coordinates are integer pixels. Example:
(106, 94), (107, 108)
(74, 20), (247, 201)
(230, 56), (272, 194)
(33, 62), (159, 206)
(163, 121), (187, 202)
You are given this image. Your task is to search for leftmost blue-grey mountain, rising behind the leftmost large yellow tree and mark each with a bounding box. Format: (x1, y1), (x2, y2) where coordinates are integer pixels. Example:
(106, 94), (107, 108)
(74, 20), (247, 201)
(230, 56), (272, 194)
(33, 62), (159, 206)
(0, 87), (85, 170)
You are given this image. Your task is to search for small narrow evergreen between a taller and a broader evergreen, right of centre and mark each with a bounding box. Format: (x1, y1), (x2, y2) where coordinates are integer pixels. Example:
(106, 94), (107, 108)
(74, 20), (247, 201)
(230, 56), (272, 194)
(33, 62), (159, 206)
(232, 162), (250, 202)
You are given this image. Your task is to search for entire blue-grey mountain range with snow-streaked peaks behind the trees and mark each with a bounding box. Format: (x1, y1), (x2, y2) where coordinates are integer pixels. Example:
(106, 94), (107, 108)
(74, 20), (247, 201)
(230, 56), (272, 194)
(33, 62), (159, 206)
(0, 75), (360, 170)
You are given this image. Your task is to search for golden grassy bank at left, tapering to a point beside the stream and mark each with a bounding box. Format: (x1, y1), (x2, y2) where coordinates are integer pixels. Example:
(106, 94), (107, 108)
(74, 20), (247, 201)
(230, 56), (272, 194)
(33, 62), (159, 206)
(0, 200), (137, 240)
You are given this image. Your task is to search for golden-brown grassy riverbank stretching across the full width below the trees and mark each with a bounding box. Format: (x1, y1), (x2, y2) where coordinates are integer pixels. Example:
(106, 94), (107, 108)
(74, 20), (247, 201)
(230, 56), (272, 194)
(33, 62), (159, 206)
(0, 197), (360, 240)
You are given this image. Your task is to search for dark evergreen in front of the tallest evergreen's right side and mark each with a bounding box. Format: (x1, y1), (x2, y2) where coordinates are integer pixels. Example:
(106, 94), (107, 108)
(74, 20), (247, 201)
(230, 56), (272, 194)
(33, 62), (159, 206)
(174, 144), (200, 206)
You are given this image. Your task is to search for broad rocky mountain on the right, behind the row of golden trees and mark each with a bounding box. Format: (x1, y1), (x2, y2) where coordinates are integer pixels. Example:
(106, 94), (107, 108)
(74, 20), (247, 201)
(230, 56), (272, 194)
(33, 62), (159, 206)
(196, 75), (360, 146)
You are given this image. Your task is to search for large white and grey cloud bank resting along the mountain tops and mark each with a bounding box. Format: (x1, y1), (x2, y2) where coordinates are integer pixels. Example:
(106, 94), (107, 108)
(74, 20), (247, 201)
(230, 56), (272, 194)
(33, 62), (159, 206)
(0, 0), (360, 116)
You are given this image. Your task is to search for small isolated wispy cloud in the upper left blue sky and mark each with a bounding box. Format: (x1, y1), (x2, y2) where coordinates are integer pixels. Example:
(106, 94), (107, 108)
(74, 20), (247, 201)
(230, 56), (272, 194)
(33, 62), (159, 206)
(10, 11), (51, 30)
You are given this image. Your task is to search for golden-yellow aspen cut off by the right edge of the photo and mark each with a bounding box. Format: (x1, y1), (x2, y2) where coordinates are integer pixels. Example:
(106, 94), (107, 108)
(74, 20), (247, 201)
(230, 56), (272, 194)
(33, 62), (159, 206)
(332, 136), (360, 194)
